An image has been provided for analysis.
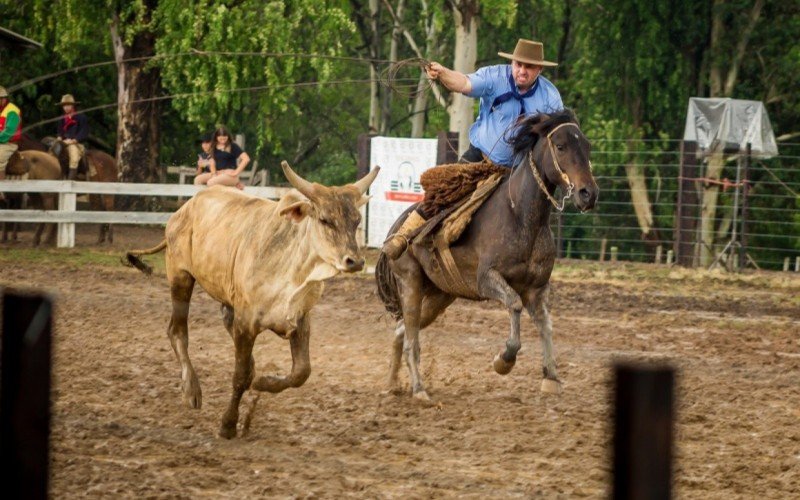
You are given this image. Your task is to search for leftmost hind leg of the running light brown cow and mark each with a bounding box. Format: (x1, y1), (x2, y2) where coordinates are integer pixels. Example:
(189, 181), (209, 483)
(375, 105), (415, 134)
(167, 271), (203, 408)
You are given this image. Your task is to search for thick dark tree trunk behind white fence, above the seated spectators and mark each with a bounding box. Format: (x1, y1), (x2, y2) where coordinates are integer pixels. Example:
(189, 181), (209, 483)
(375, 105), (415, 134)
(111, 16), (161, 189)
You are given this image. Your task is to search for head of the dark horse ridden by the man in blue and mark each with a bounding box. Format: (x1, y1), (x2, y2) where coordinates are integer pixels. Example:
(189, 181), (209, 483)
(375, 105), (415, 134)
(512, 110), (600, 212)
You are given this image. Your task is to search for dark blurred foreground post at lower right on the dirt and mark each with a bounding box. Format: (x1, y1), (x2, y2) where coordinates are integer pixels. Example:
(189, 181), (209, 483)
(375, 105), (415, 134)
(613, 364), (675, 500)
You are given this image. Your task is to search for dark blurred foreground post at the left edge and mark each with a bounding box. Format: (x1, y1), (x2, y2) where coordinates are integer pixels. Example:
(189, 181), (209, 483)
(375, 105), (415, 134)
(0, 289), (53, 499)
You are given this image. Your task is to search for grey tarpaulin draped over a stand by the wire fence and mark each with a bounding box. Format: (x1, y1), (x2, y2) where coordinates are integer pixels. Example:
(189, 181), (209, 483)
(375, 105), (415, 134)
(683, 97), (778, 158)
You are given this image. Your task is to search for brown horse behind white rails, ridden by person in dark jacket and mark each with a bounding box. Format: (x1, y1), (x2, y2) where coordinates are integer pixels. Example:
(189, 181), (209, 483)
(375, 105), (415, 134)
(42, 137), (119, 243)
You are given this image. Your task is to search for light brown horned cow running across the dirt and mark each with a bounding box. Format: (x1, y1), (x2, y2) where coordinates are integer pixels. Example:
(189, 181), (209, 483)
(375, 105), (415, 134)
(127, 162), (378, 438)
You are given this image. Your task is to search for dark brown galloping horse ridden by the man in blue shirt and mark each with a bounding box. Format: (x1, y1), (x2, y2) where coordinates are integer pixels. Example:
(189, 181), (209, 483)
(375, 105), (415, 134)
(375, 111), (598, 400)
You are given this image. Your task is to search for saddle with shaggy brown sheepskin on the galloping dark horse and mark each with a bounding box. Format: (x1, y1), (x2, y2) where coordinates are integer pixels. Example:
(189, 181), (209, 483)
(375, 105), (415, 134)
(409, 163), (510, 298)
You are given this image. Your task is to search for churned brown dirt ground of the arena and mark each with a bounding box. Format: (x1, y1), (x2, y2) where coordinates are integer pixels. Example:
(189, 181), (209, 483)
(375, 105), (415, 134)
(0, 227), (800, 499)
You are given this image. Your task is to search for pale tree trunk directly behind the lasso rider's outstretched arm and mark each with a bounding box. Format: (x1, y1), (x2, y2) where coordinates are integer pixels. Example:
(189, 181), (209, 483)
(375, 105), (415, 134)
(448, 0), (478, 154)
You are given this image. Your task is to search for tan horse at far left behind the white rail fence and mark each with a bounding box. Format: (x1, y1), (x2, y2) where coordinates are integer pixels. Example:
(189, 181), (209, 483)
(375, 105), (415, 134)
(3, 150), (61, 246)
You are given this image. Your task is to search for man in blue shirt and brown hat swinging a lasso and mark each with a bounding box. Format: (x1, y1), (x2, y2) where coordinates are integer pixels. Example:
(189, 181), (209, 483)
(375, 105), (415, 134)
(383, 39), (564, 260)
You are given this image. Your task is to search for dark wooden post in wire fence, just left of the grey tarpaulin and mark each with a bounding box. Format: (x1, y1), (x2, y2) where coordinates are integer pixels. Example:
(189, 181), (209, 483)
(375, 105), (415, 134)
(674, 141), (699, 267)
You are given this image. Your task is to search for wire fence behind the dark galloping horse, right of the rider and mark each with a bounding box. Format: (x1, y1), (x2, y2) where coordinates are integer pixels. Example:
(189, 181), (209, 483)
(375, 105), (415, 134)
(552, 140), (800, 271)
